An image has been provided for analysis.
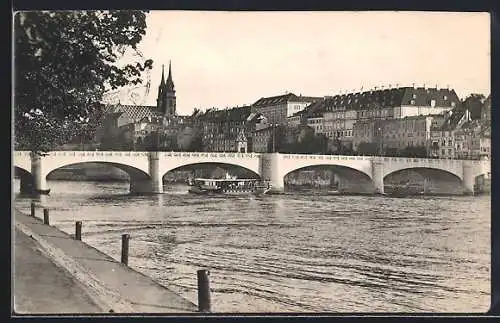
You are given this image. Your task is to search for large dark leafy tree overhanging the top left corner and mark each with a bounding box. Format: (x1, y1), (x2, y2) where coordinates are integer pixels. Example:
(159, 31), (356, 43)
(14, 10), (153, 152)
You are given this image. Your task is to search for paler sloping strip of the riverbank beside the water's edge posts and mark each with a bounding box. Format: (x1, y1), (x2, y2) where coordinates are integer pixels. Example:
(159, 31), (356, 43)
(14, 209), (197, 313)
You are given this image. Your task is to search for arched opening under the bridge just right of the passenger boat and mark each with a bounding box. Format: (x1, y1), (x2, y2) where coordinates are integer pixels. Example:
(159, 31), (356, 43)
(284, 165), (375, 194)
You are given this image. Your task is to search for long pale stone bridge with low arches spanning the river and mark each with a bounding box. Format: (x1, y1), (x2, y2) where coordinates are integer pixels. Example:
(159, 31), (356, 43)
(13, 151), (490, 194)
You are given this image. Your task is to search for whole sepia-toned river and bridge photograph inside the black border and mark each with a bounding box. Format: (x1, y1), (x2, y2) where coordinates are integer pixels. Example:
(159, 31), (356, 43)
(11, 10), (492, 316)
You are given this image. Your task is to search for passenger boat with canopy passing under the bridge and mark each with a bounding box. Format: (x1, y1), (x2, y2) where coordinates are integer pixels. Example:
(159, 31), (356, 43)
(188, 178), (271, 195)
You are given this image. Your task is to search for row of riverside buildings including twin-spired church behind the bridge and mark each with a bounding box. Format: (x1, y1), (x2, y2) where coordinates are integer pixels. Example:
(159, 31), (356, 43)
(92, 61), (491, 159)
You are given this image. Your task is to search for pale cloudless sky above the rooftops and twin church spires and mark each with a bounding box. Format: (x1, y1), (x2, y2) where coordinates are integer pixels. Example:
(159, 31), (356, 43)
(103, 11), (490, 115)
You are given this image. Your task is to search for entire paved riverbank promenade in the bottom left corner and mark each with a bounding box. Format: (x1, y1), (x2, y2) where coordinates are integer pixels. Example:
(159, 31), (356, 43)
(12, 209), (197, 314)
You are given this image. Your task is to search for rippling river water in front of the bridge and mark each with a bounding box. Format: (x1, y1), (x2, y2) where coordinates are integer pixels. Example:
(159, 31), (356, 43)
(14, 180), (491, 312)
